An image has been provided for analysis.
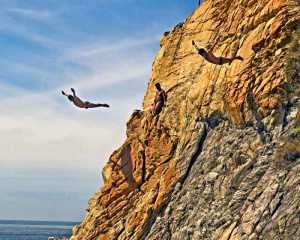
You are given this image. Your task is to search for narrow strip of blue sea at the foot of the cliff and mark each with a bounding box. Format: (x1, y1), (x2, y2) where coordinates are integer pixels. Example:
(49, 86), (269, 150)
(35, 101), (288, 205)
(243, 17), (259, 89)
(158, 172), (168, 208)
(0, 220), (78, 240)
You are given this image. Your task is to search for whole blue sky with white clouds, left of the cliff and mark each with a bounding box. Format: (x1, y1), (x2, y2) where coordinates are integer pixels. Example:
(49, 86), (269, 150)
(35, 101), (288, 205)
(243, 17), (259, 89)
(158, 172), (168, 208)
(0, 0), (198, 221)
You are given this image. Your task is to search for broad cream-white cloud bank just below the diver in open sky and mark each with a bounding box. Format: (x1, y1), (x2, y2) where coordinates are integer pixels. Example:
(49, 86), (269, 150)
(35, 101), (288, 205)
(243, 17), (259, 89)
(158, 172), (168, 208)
(0, 90), (131, 172)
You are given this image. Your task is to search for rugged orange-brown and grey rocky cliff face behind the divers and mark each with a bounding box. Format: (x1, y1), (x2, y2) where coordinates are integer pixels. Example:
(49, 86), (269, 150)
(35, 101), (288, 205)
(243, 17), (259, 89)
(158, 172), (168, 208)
(72, 0), (300, 240)
